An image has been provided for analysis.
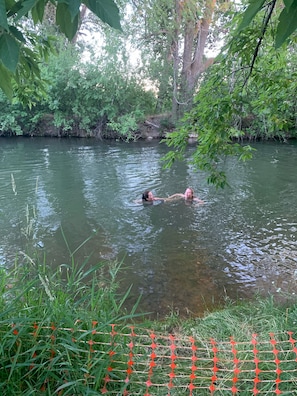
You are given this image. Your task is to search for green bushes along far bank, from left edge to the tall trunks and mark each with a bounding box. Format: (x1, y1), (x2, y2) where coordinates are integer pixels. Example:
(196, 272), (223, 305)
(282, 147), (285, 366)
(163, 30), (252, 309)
(0, 42), (156, 140)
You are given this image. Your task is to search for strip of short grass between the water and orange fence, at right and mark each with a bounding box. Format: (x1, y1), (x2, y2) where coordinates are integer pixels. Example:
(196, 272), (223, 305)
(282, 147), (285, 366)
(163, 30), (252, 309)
(154, 294), (297, 342)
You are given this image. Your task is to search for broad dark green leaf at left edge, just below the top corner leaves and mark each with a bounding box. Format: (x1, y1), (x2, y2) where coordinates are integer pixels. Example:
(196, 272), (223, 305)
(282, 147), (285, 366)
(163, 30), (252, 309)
(0, 33), (20, 73)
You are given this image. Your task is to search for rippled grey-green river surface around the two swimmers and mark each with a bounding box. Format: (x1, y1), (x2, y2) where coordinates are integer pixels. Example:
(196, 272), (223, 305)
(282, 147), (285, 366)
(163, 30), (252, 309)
(0, 138), (297, 317)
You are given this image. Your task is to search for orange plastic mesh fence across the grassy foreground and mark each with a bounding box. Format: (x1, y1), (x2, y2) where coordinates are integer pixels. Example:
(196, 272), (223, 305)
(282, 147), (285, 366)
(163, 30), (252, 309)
(6, 321), (297, 396)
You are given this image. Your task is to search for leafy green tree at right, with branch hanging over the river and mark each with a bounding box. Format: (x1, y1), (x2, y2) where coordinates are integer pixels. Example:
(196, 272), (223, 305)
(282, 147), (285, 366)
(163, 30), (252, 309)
(165, 1), (297, 187)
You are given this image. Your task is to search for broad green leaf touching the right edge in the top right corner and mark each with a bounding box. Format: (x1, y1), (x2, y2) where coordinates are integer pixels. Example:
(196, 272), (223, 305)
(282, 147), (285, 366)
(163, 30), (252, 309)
(275, 0), (297, 48)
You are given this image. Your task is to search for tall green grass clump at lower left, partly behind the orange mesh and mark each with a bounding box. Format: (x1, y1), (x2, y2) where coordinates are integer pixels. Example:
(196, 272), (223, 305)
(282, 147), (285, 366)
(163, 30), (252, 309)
(0, 246), (140, 395)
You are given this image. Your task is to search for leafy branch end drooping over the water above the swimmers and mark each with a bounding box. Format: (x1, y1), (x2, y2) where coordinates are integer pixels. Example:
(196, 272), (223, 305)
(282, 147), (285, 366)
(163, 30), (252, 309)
(164, 63), (252, 187)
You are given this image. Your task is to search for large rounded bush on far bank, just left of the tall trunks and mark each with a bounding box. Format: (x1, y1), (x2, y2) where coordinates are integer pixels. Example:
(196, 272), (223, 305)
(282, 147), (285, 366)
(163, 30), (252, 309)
(40, 44), (155, 138)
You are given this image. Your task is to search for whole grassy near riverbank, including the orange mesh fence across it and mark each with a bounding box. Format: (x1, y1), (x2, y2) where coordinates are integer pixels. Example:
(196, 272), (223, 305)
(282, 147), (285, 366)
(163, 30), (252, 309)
(0, 254), (297, 395)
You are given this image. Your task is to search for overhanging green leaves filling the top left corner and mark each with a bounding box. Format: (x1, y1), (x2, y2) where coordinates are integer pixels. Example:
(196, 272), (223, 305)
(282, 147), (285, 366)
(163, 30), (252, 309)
(0, 0), (121, 100)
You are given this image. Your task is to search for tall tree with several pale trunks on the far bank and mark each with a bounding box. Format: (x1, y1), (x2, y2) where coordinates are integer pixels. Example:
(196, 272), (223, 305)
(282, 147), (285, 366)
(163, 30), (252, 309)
(130, 0), (226, 120)
